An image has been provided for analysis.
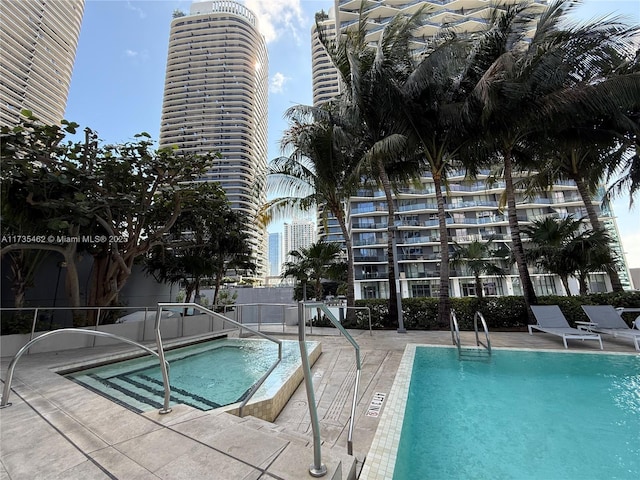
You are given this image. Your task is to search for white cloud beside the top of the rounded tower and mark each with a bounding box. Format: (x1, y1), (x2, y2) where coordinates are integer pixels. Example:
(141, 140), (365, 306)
(244, 0), (309, 43)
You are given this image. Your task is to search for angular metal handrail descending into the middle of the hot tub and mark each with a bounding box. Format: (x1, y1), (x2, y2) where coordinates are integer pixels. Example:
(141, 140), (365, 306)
(155, 303), (282, 416)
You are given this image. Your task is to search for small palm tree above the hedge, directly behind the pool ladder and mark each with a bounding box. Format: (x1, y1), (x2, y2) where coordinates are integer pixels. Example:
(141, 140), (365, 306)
(451, 240), (506, 298)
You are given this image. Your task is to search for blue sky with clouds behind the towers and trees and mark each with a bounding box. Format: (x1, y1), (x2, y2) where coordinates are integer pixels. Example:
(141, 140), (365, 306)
(65, 0), (640, 268)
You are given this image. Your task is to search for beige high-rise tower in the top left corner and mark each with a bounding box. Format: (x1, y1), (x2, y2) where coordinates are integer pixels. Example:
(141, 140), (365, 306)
(0, 0), (84, 126)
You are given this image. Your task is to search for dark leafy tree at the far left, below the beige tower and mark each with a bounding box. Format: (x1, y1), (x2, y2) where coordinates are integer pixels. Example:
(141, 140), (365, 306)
(0, 114), (95, 319)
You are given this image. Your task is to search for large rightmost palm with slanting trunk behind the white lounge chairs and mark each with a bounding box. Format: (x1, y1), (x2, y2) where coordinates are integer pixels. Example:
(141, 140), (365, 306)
(470, 0), (638, 305)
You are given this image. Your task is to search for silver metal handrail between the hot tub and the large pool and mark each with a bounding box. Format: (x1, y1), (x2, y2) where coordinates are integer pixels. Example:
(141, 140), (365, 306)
(298, 302), (362, 477)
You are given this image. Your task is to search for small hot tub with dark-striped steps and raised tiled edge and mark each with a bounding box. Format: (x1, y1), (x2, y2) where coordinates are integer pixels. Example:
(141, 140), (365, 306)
(65, 339), (320, 419)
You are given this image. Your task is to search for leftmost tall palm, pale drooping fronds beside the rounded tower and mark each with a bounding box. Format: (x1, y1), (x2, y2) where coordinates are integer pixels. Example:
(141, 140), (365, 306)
(261, 104), (360, 317)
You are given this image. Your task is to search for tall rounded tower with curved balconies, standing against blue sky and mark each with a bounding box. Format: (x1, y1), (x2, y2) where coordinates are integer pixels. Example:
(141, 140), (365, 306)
(160, 0), (269, 277)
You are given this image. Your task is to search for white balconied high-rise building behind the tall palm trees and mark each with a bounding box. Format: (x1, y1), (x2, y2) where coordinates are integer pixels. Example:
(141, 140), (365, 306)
(311, 0), (630, 298)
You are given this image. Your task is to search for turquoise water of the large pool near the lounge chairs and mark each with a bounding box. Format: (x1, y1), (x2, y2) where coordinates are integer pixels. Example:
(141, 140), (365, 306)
(393, 347), (640, 480)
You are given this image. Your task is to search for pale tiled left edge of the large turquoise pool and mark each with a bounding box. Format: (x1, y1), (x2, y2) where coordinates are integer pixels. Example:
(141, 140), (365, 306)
(359, 344), (416, 480)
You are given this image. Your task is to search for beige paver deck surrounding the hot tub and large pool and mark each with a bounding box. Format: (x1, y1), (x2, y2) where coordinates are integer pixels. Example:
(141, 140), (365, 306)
(0, 328), (637, 480)
